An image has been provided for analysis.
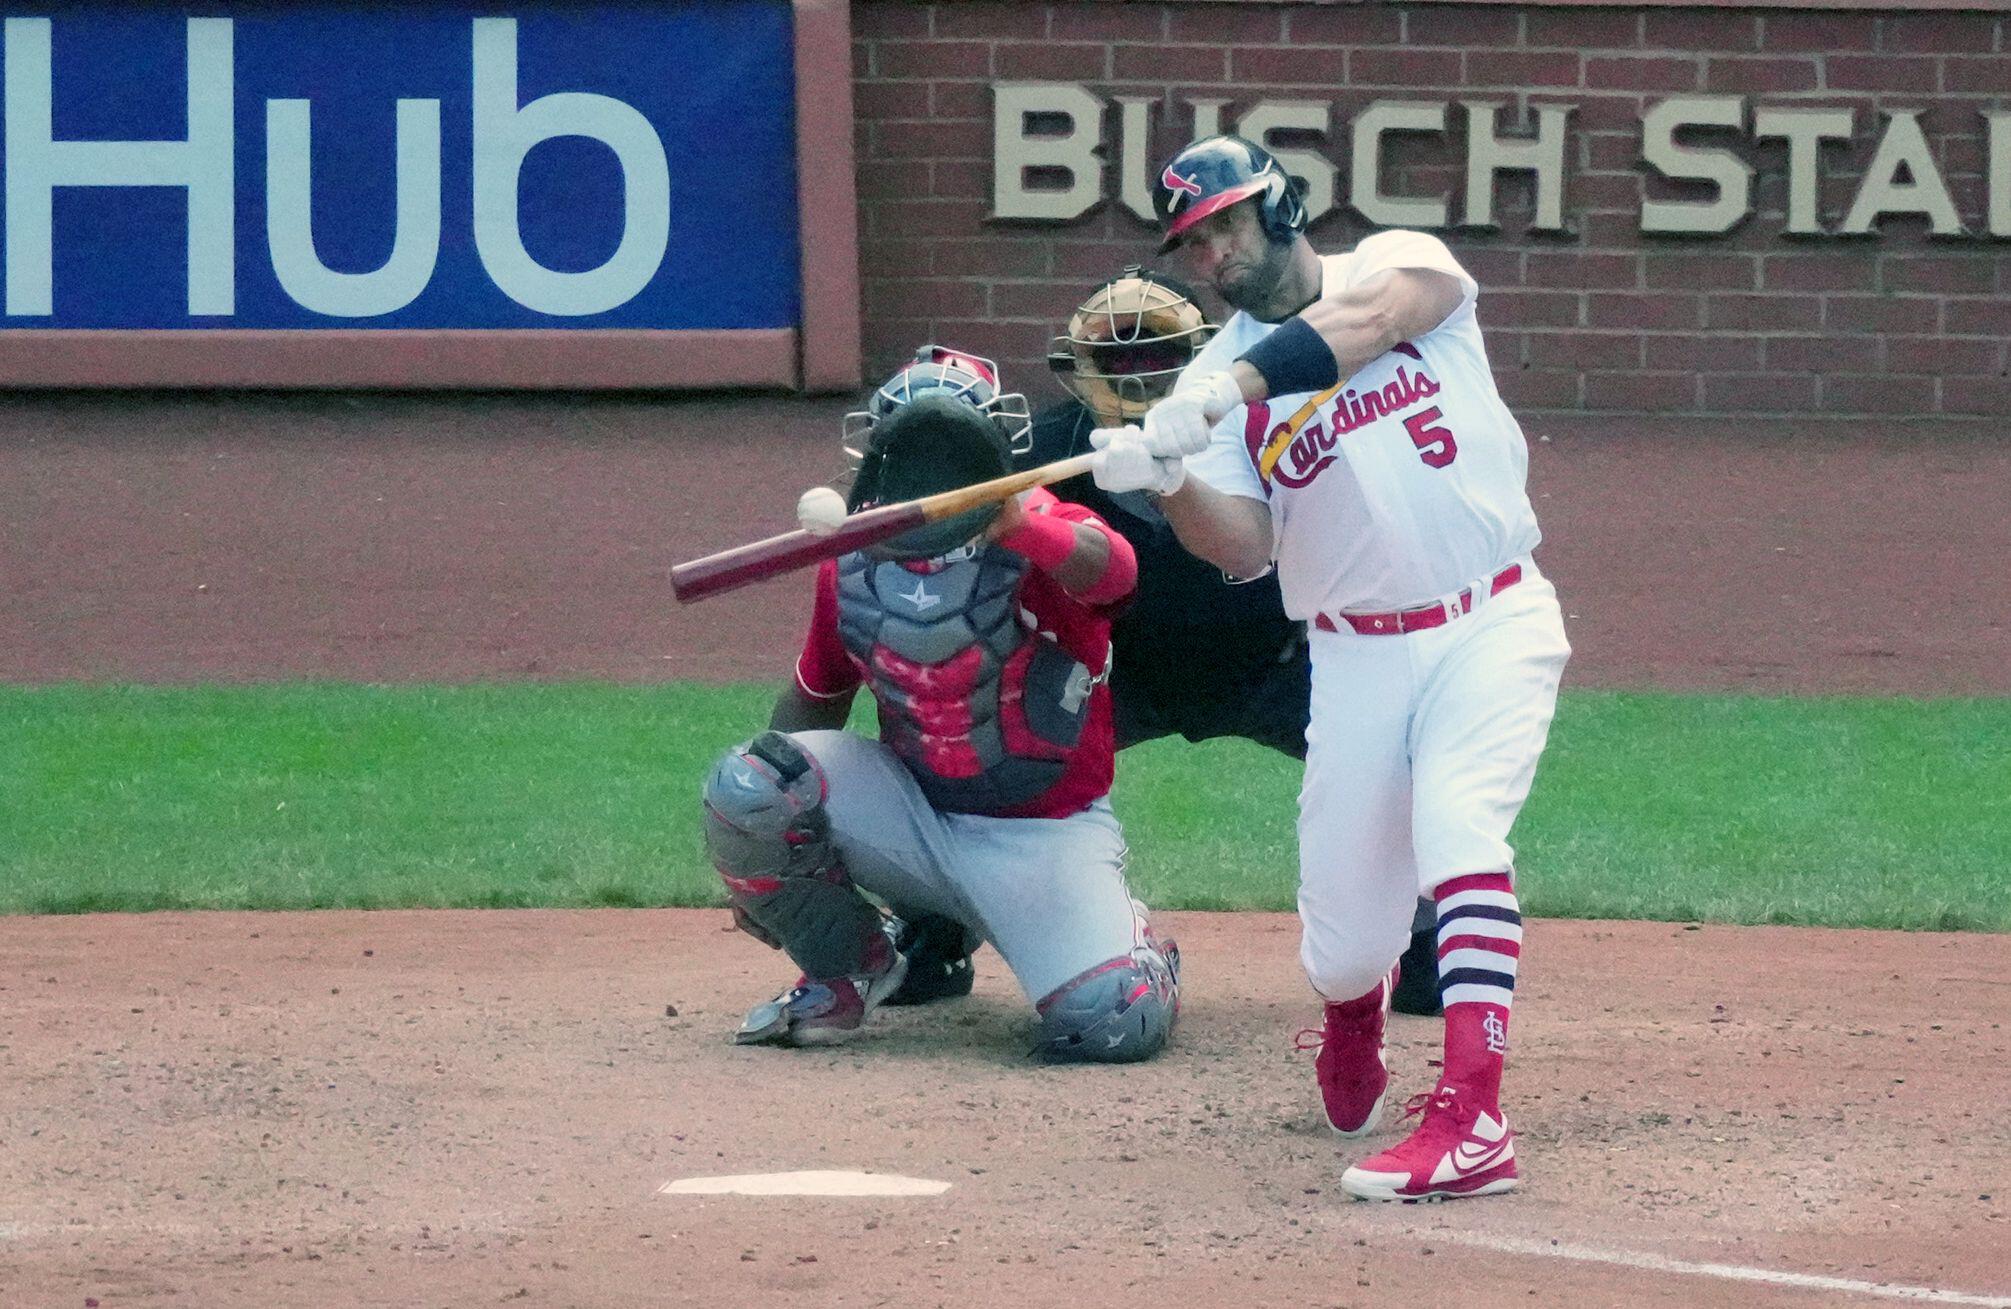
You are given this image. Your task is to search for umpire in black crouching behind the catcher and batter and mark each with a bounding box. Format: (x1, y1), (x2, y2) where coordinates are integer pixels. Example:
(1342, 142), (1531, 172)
(889, 267), (1440, 1015)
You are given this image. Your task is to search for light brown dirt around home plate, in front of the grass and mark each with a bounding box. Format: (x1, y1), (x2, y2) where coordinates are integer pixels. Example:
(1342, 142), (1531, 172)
(0, 911), (2011, 1309)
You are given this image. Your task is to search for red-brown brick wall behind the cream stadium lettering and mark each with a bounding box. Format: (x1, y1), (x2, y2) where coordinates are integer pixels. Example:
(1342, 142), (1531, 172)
(853, 0), (2011, 414)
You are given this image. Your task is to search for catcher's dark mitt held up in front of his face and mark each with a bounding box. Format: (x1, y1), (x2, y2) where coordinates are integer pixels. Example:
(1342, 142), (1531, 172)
(847, 394), (1012, 559)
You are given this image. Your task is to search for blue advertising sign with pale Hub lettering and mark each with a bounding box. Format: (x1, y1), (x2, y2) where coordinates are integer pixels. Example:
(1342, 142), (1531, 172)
(0, 0), (800, 330)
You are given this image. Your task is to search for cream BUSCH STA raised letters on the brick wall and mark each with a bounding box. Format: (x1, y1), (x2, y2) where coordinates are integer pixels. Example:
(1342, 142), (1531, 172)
(991, 80), (2011, 239)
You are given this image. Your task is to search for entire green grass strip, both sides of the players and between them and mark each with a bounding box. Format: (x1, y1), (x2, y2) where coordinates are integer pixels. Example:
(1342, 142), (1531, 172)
(0, 684), (2011, 931)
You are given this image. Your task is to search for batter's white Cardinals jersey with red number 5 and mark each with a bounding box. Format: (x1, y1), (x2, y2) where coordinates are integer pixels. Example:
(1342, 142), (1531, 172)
(1180, 231), (1540, 619)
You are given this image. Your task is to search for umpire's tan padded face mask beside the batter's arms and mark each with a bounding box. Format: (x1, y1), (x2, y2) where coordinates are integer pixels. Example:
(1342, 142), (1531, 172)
(1048, 265), (1215, 426)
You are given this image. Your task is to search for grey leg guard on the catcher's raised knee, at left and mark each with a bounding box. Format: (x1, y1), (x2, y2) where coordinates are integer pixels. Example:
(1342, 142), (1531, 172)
(704, 732), (883, 977)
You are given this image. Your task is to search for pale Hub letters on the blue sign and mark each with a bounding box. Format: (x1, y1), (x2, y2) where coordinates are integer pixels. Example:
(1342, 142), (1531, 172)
(6, 18), (670, 318)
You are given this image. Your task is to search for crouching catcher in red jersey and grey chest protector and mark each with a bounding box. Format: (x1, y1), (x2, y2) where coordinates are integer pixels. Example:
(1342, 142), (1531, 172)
(704, 348), (1178, 1062)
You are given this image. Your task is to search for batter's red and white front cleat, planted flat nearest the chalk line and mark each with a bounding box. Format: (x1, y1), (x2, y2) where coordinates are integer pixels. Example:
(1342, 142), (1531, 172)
(1341, 1082), (1520, 1202)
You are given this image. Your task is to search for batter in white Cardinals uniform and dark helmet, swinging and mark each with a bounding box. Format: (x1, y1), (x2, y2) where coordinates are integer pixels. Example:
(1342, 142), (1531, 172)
(1096, 137), (1571, 1200)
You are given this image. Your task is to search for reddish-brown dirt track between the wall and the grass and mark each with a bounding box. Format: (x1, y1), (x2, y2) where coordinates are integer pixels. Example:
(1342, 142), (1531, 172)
(0, 396), (2011, 694)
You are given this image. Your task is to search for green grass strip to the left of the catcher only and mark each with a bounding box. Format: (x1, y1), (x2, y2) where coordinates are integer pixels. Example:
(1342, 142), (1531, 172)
(0, 686), (768, 911)
